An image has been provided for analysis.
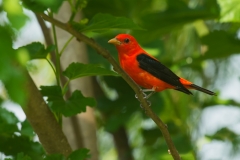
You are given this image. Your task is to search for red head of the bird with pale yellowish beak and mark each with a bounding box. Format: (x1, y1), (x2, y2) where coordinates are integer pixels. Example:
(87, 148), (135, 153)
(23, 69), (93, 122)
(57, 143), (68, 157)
(108, 34), (141, 55)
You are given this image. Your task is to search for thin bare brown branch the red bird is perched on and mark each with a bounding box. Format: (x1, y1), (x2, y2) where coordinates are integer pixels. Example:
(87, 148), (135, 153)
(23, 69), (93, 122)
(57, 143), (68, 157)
(41, 14), (181, 160)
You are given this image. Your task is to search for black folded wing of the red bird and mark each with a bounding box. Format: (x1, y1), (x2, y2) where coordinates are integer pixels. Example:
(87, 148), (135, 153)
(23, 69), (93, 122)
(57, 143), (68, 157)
(137, 54), (192, 94)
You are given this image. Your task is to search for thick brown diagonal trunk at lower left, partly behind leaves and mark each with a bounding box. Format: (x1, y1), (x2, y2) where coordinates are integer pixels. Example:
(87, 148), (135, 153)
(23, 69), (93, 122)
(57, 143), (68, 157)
(23, 74), (72, 157)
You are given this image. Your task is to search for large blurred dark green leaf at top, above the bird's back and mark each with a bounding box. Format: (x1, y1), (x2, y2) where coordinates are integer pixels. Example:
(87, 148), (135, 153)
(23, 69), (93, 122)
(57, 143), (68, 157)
(133, 0), (220, 43)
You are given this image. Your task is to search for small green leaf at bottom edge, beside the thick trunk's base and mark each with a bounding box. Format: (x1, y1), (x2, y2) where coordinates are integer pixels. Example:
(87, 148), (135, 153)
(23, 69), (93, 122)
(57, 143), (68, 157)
(67, 148), (91, 160)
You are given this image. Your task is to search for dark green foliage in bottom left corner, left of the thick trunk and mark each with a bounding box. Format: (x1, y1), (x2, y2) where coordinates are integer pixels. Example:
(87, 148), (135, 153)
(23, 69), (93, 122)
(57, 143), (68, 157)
(0, 107), (44, 160)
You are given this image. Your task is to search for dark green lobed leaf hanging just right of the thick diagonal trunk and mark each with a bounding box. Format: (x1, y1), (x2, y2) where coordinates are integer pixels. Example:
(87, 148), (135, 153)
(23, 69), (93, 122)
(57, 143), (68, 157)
(49, 90), (96, 117)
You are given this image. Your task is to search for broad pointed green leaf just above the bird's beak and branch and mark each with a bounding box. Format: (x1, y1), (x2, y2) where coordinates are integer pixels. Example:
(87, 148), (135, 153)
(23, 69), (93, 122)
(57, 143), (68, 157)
(81, 13), (143, 32)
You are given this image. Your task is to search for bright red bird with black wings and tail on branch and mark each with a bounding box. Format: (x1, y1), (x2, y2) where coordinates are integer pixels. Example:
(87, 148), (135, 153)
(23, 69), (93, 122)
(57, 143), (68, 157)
(108, 34), (215, 98)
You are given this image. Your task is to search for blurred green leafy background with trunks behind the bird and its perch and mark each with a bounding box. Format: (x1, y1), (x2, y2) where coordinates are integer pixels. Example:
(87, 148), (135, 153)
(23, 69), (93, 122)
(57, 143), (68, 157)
(0, 0), (240, 160)
